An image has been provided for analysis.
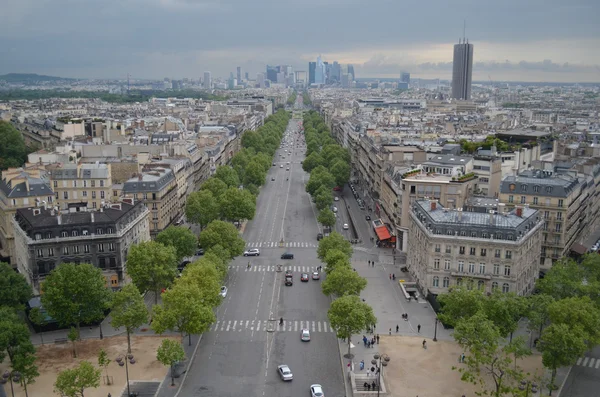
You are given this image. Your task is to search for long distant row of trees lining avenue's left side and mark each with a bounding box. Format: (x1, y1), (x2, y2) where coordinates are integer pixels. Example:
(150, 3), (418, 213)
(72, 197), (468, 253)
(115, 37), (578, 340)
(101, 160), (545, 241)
(185, 110), (290, 229)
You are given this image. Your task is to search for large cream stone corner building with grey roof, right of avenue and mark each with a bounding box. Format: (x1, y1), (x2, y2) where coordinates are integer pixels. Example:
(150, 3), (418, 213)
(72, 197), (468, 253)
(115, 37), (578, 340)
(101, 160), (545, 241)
(407, 200), (544, 298)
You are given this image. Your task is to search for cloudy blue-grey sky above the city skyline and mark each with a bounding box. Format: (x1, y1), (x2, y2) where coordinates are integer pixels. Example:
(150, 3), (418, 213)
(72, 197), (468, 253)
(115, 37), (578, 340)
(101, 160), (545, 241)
(0, 0), (600, 82)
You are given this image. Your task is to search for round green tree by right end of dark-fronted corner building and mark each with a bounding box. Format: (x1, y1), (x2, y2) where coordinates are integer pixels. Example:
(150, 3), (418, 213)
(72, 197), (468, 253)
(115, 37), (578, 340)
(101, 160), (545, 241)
(127, 241), (177, 303)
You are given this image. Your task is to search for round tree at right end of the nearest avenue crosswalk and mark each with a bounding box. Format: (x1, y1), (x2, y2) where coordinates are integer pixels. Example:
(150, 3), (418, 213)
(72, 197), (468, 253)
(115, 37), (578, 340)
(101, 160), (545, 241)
(327, 295), (377, 355)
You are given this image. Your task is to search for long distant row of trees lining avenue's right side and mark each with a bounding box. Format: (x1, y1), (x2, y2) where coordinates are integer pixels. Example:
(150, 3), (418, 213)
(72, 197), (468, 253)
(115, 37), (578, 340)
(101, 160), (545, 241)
(302, 111), (350, 227)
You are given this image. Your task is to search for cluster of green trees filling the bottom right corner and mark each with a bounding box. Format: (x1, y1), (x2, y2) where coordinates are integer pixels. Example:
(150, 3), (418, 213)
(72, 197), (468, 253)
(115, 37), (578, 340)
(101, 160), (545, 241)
(438, 254), (600, 397)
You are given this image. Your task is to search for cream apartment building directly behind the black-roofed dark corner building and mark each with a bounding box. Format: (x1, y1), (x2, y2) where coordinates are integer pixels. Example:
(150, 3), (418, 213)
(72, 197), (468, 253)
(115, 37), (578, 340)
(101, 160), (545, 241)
(46, 162), (113, 210)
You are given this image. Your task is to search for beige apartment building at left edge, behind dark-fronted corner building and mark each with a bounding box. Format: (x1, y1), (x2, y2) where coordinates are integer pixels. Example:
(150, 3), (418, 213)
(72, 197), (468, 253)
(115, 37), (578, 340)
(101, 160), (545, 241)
(0, 165), (54, 264)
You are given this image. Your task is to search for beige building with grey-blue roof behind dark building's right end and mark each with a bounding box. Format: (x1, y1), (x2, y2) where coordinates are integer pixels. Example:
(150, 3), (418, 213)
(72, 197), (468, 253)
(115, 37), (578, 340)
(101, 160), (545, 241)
(122, 168), (177, 238)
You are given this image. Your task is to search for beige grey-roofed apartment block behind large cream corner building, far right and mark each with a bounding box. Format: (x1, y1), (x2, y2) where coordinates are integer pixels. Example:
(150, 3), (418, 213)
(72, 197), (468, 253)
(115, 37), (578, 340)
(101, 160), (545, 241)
(500, 170), (597, 269)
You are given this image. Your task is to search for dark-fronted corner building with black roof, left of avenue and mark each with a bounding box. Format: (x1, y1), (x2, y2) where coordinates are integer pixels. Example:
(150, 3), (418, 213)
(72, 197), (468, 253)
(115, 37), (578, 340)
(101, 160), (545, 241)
(12, 202), (150, 294)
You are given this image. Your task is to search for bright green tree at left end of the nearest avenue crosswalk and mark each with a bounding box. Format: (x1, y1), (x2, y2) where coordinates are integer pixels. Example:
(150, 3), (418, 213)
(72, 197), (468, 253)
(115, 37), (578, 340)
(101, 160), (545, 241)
(152, 282), (216, 346)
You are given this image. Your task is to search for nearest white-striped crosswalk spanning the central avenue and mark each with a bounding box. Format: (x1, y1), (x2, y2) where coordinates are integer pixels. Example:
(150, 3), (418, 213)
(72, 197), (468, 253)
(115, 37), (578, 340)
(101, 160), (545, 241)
(210, 320), (335, 332)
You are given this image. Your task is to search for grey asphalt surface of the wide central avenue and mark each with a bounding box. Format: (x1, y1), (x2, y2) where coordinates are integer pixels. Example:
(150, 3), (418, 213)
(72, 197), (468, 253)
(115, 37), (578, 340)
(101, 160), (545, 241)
(180, 119), (345, 397)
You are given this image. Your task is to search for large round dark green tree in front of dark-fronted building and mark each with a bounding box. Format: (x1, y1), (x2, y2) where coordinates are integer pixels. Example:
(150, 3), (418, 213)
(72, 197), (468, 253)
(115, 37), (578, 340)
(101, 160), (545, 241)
(42, 263), (111, 332)
